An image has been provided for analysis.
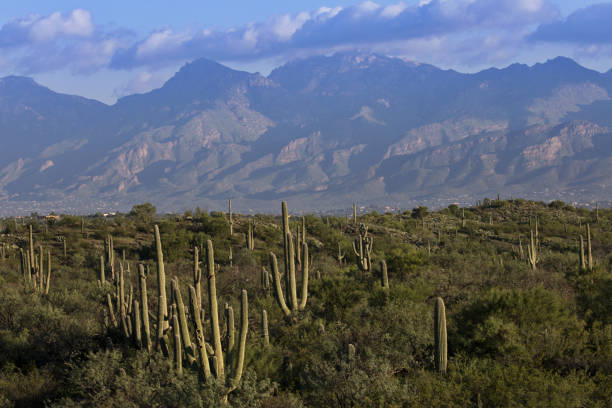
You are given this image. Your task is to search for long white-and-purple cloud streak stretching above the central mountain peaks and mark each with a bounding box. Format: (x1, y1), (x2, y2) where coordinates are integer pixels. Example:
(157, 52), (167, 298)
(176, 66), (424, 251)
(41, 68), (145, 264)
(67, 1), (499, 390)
(111, 0), (559, 69)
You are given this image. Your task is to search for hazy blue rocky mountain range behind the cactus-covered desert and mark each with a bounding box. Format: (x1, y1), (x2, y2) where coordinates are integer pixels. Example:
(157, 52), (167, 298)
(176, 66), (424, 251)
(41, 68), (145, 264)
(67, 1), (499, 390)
(0, 53), (612, 214)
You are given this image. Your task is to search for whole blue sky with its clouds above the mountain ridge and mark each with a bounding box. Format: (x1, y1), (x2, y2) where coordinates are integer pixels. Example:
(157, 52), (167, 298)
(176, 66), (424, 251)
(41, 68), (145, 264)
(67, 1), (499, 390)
(0, 0), (612, 103)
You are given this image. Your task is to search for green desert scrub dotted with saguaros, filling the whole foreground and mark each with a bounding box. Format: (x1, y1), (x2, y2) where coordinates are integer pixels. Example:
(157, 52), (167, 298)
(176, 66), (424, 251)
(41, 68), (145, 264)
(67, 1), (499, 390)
(0, 198), (612, 407)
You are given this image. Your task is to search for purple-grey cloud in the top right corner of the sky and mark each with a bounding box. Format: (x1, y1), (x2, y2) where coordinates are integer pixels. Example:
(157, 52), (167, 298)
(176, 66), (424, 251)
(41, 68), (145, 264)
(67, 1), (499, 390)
(530, 3), (612, 44)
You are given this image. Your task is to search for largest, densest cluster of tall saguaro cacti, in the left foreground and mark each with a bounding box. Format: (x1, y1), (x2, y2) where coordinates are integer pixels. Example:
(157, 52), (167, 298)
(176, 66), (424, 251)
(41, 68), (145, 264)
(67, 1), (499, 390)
(106, 225), (248, 395)
